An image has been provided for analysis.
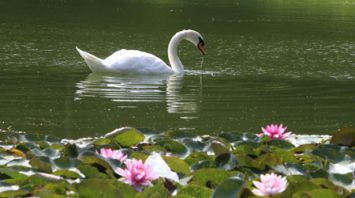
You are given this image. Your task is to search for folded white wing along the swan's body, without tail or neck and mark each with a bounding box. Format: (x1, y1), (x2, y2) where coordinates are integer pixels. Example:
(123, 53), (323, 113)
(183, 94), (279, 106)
(103, 49), (173, 73)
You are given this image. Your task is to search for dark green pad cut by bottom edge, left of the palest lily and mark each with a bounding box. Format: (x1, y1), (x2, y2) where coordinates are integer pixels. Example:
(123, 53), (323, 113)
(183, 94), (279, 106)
(211, 177), (244, 198)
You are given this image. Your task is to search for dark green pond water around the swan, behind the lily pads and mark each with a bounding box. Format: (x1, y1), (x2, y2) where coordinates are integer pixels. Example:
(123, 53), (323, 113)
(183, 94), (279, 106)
(0, 0), (355, 137)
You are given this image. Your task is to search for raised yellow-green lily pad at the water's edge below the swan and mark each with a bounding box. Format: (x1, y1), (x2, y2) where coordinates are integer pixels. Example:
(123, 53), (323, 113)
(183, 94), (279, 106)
(105, 127), (144, 147)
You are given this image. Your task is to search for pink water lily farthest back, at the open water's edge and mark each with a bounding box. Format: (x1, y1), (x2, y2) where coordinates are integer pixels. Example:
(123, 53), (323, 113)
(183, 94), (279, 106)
(257, 124), (291, 140)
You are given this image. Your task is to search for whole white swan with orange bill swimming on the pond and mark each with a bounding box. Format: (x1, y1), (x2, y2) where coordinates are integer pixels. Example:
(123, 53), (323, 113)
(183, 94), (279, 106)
(76, 30), (205, 74)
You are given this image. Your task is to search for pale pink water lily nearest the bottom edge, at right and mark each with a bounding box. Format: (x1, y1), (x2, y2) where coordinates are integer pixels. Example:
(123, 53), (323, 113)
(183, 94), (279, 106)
(252, 173), (287, 196)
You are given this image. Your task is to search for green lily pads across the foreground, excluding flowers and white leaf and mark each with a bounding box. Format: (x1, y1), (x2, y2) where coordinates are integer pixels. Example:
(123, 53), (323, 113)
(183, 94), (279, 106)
(0, 128), (355, 197)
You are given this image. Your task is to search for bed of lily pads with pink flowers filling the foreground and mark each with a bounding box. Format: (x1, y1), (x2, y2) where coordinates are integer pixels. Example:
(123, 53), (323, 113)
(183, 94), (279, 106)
(0, 125), (355, 198)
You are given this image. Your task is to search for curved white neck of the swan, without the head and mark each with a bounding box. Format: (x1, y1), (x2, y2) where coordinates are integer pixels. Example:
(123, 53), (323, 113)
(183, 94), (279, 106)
(168, 32), (185, 73)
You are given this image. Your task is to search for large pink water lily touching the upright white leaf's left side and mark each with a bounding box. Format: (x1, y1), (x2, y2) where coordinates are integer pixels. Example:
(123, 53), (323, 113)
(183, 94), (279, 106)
(115, 159), (158, 191)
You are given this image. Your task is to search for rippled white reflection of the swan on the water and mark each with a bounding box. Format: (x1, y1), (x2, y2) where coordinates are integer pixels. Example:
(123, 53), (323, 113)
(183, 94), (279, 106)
(75, 73), (202, 114)
